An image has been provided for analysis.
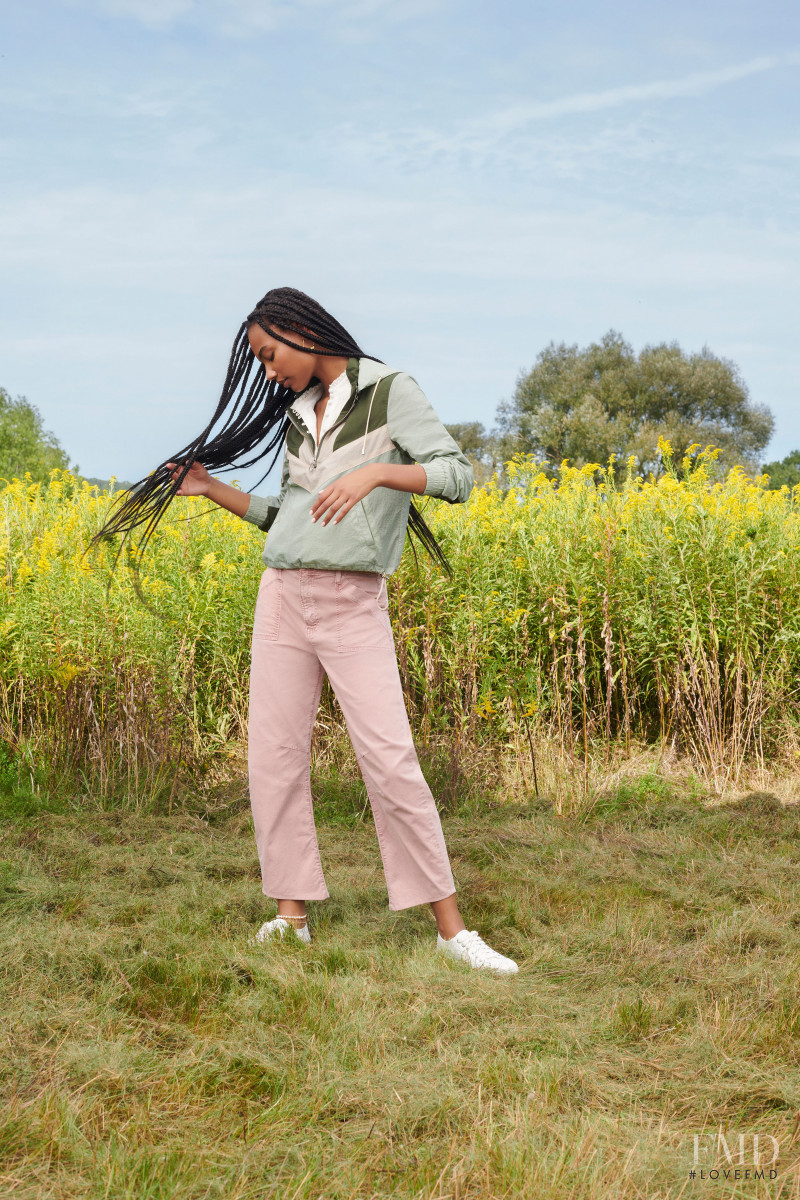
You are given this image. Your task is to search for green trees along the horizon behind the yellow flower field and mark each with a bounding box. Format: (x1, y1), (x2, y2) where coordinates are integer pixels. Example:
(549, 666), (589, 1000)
(0, 329), (800, 488)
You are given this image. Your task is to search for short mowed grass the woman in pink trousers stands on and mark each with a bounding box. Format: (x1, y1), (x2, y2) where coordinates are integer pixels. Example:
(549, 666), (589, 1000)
(0, 776), (800, 1200)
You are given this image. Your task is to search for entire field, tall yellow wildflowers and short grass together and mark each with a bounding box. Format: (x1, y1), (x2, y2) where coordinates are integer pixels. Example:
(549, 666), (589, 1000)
(0, 454), (800, 1200)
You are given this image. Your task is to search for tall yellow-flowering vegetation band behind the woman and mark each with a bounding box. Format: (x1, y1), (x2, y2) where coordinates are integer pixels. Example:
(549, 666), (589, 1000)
(0, 451), (800, 806)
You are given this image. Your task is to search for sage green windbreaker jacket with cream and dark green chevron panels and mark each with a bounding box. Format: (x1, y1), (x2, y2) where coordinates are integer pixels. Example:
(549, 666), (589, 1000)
(245, 359), (474, 575)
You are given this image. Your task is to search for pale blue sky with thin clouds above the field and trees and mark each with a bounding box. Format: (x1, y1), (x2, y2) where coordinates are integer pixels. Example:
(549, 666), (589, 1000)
(0, 0), (800, 491)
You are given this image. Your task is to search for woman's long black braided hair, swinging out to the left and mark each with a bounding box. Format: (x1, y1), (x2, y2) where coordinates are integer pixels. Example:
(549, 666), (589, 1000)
(92, 288), (452, 575)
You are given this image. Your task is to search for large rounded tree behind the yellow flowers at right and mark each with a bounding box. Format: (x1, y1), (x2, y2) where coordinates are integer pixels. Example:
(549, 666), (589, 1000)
(495, 330), (774, 476)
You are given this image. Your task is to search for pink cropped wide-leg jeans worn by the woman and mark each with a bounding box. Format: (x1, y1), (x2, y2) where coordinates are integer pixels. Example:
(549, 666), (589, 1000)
(248, 566), (456, 911)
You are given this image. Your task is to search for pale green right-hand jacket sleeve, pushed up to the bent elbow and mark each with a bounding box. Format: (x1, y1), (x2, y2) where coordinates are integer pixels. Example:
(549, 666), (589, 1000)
(386, 374), (475, 504)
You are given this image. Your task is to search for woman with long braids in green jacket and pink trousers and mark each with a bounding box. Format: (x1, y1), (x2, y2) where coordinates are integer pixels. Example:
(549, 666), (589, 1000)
(103, 288), (518, 973)
